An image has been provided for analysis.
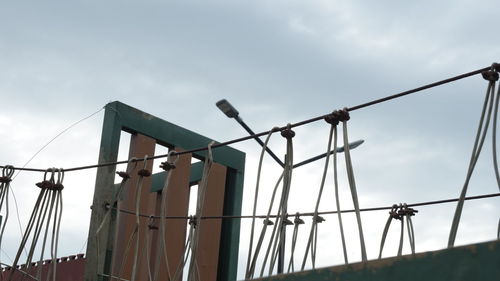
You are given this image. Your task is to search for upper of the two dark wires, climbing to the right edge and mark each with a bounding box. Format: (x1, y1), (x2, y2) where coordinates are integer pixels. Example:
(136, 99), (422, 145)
(0, 63), (500, 172)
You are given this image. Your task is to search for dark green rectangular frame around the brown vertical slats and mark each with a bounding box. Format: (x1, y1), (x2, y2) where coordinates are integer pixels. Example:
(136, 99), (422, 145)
(84, 101), (245, 281)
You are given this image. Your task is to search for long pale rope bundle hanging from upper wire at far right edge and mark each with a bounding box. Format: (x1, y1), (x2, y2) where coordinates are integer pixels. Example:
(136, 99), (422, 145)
(448, 65), (500, 248)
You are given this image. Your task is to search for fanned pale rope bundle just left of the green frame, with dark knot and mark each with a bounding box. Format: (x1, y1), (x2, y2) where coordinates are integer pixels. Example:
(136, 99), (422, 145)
(9, 168), (64, 281)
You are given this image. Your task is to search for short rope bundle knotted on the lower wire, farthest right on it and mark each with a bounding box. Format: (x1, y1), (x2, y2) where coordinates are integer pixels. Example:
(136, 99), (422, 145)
(378, 203), (418, 259)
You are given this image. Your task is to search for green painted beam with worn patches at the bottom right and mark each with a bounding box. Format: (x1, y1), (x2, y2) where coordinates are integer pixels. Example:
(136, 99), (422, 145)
(256, 240), (500, 281)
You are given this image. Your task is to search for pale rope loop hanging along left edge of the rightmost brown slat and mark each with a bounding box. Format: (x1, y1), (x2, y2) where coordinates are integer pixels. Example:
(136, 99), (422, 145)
(188, 141), (215, 281)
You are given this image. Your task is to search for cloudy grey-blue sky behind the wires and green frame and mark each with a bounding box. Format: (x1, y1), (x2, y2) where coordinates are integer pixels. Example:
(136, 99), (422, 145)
(0, 0), (500, 276)
